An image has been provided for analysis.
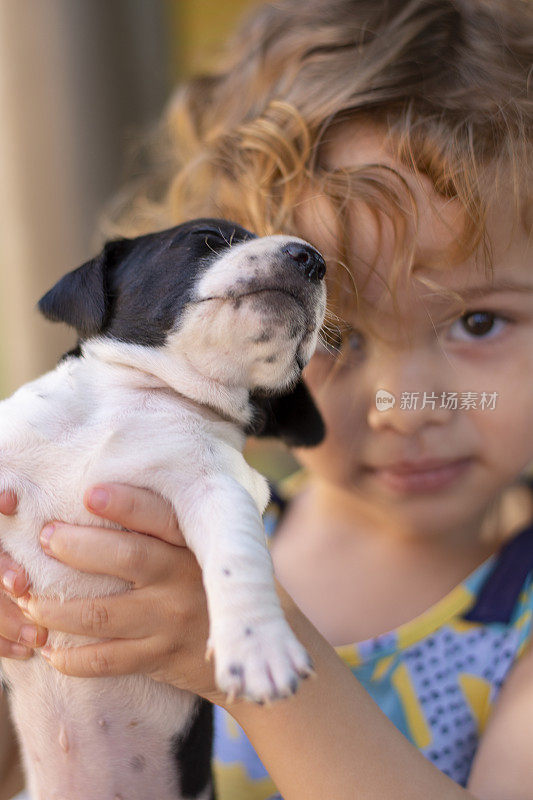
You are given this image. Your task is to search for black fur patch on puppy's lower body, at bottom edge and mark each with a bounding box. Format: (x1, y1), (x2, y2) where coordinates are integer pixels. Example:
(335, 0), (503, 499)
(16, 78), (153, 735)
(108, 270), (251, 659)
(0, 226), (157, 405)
(172, 699), (215, 800)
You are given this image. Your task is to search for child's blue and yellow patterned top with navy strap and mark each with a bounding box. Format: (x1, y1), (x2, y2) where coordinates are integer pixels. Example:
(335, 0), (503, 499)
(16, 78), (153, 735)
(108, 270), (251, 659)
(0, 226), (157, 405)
(214, 478), (533, 800)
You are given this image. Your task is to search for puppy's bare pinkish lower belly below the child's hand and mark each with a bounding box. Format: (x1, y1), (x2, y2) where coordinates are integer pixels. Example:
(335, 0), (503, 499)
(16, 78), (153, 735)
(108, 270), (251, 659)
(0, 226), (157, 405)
(2, 655), (210, 800)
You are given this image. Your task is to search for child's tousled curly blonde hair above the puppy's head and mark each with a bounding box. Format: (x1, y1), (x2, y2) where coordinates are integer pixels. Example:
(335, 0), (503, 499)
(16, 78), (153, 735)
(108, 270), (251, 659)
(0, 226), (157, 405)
(102, 0), (533, 326)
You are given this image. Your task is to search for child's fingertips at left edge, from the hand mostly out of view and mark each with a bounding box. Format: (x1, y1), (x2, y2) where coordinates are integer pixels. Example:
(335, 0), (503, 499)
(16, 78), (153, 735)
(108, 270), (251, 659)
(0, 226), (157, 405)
(0, 492), (48, 658)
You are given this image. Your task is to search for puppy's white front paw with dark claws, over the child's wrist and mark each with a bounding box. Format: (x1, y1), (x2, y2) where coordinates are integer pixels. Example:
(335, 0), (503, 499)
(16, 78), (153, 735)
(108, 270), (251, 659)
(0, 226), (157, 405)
(210, 619), (313, 704)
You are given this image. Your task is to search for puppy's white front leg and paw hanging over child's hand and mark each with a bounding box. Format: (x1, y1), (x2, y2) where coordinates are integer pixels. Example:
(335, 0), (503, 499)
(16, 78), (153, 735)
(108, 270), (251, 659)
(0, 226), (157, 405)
(176, 475), (312, 703)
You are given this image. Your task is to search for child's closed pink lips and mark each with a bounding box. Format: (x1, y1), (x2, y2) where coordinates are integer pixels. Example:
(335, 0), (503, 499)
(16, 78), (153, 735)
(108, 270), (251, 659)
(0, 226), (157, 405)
(367, 457), (472, 493)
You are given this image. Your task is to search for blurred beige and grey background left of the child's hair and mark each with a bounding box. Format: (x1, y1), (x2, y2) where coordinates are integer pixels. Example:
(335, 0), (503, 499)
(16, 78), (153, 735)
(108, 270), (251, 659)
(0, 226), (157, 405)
(0, 0), (258, 397)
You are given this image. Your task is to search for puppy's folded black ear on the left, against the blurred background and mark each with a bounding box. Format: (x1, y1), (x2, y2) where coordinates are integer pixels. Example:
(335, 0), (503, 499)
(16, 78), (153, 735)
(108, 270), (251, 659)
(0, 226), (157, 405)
(37, 239), (132, 338)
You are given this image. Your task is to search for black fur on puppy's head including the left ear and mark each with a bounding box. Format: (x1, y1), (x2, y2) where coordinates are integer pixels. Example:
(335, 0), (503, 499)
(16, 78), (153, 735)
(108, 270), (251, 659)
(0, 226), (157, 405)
(38, 219), (256, 346)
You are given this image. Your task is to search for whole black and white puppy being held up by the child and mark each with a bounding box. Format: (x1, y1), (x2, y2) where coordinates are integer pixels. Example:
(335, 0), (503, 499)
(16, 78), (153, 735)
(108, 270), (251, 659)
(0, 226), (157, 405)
(0, 219), (325, 800)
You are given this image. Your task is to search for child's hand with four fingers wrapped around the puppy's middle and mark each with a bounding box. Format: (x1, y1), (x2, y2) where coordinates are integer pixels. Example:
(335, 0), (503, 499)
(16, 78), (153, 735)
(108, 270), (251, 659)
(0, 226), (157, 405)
(5, 484), (224, 702)
